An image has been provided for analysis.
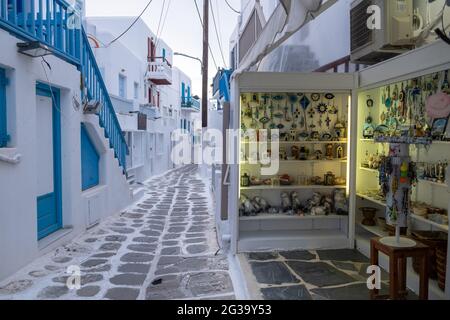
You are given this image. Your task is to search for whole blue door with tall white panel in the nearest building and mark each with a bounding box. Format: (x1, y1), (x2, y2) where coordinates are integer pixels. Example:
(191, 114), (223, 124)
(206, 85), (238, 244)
(36, 84), (62, 240)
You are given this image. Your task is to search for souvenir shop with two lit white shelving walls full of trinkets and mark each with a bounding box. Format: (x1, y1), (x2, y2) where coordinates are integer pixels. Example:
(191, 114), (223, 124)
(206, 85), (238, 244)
(228, 42), (450, 298)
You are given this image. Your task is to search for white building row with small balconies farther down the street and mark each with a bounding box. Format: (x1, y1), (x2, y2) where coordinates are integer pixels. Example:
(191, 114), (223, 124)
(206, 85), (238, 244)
(87, 17), (200, 186)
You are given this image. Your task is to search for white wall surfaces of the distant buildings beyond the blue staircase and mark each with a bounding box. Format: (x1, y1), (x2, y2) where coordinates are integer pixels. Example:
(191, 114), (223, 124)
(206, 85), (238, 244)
(87, 17), (200, 182)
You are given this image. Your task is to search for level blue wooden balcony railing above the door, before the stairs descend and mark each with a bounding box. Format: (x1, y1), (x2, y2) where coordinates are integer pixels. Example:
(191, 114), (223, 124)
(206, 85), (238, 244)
(0, 0), (81, 65)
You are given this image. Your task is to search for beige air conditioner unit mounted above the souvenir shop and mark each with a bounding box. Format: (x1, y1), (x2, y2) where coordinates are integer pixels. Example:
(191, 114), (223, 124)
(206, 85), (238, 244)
(350, 0), (415, 65)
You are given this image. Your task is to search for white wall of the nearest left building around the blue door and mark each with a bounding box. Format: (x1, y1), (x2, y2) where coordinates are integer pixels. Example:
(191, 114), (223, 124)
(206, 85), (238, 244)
(0, 30), (131, 279)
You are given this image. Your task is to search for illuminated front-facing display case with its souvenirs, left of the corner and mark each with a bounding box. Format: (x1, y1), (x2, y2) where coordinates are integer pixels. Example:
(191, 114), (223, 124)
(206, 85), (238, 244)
(230, 73), (354, 252)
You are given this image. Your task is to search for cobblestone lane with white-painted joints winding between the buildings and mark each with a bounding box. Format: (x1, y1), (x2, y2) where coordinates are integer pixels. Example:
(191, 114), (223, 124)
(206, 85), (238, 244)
(0, 166), (235, 300)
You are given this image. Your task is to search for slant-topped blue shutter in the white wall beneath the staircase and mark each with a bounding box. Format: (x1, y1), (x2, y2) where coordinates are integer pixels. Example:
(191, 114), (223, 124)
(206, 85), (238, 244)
(81, 124), (100, 191)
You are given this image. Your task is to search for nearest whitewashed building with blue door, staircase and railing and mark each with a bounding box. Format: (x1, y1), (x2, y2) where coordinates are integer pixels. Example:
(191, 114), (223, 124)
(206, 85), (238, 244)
(0, 0), (135, 279)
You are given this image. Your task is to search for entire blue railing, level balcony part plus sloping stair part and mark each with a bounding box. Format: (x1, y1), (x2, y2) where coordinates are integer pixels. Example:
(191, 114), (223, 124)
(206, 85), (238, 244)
(0, 0), (128, 172)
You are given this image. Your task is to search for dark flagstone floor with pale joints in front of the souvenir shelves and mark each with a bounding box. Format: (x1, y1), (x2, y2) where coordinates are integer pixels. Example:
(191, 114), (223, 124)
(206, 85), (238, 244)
(244, 250), (417, 300)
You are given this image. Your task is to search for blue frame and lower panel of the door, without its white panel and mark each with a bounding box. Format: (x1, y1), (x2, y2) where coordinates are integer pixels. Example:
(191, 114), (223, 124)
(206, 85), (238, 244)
(36, 83), (62, 240)
